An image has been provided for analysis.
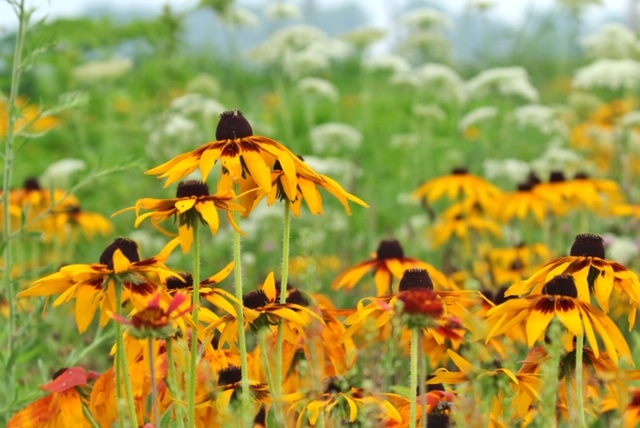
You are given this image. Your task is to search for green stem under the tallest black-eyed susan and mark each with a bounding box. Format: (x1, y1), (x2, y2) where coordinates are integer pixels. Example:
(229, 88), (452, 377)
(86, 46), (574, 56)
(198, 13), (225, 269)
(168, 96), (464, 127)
(233, 206), (251, 425)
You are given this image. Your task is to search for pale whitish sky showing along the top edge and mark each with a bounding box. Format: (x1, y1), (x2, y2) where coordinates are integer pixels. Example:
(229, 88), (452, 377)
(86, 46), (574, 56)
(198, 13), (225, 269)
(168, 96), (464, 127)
(0, 0), (630, 34)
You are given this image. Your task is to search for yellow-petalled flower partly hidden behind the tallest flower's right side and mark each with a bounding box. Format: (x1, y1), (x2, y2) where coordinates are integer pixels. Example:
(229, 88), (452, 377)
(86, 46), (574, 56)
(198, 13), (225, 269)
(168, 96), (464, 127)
(253, 156), (369, 217)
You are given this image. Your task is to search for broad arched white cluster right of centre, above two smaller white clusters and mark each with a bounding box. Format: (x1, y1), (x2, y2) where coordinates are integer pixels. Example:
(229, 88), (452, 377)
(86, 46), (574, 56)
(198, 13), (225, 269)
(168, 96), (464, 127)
(465, 67), (539, 102)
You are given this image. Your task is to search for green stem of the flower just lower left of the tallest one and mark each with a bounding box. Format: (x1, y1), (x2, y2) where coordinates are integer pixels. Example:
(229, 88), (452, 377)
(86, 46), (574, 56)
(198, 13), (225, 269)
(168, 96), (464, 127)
(187, 221), (200, 428)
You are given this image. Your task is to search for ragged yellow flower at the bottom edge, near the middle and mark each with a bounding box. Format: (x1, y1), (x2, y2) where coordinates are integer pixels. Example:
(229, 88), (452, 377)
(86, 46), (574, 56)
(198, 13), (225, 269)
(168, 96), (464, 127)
(282, 376), (402, 428)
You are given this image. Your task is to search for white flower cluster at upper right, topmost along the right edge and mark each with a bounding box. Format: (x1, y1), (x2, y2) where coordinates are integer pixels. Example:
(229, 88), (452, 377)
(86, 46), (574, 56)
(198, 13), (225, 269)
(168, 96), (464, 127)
(580, 24), (640, 59)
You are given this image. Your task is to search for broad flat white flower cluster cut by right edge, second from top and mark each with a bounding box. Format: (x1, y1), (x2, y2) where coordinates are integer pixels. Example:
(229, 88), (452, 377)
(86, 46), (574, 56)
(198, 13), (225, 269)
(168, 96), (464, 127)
(572, 59), (640, 91)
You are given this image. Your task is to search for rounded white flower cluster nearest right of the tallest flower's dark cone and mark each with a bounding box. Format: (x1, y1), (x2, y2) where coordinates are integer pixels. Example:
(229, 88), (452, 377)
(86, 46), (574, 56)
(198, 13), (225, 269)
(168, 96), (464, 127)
(311, 122), (362, 155)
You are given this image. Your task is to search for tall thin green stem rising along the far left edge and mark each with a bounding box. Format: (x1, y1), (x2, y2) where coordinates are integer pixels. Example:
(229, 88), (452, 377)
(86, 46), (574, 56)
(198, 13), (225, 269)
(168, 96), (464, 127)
(2, 0), (31, 378)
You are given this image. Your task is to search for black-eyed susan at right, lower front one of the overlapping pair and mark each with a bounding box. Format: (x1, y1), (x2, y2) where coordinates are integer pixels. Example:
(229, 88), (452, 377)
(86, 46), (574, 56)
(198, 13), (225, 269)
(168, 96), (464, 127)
(487, 274), (631, 364)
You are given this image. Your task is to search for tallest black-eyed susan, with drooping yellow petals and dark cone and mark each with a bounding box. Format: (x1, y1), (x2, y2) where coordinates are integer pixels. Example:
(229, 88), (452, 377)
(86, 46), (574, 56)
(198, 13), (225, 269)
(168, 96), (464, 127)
(146, 110), (316, 195)
